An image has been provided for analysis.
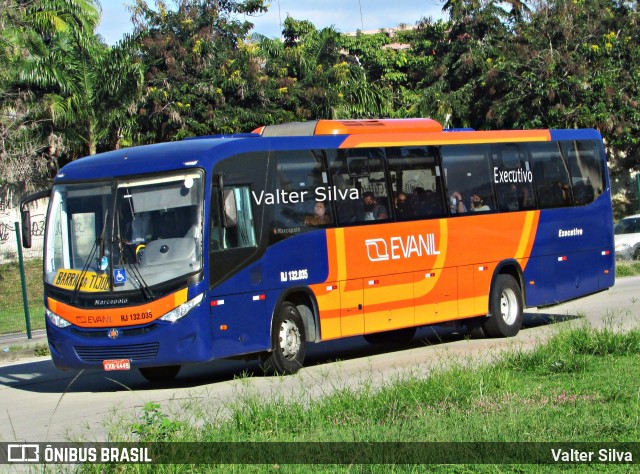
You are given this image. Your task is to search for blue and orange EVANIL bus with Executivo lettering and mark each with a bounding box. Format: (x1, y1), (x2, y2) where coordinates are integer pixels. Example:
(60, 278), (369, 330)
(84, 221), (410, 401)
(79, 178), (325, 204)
(21, 119), (615, 381)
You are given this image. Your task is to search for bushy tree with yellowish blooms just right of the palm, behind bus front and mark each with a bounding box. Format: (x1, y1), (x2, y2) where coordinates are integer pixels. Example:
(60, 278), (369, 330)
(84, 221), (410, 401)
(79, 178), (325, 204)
(133, 0), (264, 143)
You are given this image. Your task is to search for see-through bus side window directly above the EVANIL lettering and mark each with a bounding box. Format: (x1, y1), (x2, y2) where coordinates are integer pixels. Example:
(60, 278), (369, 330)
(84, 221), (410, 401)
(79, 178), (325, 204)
(387, 146), (446, 221)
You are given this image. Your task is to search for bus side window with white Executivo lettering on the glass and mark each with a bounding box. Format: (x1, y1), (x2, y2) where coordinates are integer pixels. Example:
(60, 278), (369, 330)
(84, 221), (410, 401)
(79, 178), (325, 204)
(492, 143), (536, 212)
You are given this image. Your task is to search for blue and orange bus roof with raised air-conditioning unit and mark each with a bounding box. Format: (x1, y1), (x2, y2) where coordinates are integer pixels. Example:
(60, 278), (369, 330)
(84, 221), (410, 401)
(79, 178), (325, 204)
(56, 118), (600, 181)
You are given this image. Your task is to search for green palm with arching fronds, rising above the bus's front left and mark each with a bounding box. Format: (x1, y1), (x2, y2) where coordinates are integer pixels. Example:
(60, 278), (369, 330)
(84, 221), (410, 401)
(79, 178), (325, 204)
(19, 0), (142, 159)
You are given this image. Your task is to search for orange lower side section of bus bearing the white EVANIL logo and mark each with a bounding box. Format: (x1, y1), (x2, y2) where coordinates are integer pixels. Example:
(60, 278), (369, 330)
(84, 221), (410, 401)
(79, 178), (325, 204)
(312, 211), (540, 340)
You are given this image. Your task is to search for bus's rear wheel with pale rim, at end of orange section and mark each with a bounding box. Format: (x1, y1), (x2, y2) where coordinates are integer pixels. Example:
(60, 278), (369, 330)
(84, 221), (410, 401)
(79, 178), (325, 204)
(482, 274), (523, 337)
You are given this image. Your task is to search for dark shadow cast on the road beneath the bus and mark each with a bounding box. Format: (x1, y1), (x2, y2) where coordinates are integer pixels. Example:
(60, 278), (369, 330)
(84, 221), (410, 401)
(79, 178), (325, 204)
(0, 312), (580, 394)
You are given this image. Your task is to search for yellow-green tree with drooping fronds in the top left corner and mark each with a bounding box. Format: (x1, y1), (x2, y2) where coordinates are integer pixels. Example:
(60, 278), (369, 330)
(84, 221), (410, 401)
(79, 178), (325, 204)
(0, 0), (98, 196)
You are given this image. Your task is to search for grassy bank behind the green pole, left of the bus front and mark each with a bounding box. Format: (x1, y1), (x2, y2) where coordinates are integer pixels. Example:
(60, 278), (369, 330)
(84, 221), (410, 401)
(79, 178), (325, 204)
(0, 260), (44, 334)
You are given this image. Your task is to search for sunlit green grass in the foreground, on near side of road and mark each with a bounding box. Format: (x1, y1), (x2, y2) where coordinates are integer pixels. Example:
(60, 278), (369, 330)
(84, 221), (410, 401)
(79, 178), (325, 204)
(79, 325), (640, 472)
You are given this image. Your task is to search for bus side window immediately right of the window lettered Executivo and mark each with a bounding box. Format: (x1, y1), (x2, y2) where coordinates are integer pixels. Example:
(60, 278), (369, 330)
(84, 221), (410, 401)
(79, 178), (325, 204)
(529, 142), (573, 209)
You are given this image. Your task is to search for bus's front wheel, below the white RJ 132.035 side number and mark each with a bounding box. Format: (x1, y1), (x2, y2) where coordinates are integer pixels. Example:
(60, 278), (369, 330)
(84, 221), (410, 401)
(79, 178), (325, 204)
(262, 301), (307, 375)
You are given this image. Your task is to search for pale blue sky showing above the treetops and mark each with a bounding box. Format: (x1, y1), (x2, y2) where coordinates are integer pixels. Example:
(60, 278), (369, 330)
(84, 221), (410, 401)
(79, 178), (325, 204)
(98, 0), (445, 45)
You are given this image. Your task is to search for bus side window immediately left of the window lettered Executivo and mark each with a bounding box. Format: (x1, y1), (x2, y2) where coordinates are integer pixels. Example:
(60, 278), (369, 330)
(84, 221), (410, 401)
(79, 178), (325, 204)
(440, 145), (496, 214)
